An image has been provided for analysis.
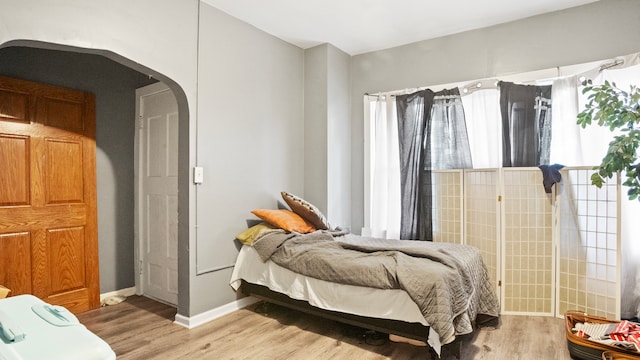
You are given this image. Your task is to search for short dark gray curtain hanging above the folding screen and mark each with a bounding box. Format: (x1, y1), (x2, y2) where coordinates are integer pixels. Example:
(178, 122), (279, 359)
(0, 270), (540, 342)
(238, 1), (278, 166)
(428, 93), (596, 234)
(498, 81), (551, 167)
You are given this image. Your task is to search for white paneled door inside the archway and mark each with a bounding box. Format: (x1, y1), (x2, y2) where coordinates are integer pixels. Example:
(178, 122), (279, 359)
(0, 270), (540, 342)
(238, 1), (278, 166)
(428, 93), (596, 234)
(135, 83), (178, 305)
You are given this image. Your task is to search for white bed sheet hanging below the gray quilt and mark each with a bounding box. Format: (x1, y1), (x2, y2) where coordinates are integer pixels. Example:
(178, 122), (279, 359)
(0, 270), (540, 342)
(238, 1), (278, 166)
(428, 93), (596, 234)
(230, 246), (441, 354)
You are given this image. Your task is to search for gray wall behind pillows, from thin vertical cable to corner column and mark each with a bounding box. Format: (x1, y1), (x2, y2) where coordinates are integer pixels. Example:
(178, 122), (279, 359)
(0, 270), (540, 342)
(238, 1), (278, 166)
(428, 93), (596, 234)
(191, 4), (304, 313)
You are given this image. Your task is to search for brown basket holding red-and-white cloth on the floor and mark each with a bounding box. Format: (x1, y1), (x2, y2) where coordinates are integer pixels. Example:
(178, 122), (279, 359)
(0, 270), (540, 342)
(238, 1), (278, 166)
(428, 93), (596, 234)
(564, 311), (640, 360)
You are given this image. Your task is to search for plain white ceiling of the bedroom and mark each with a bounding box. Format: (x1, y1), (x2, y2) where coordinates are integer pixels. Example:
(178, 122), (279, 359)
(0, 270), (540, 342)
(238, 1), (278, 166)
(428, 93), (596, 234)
(202, 0), (597, 55)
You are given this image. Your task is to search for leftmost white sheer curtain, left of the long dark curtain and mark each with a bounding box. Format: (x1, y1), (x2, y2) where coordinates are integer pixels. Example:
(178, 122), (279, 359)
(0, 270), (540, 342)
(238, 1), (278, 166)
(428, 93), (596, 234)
(362, 96), (401, 239)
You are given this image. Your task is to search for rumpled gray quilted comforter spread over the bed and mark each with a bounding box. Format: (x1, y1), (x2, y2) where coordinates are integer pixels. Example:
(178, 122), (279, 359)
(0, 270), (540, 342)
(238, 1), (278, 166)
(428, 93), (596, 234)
(253, 231), (499, 344)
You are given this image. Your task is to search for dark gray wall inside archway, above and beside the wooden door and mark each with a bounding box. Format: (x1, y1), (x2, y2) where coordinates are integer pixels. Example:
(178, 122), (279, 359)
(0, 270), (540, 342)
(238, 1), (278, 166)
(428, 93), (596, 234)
(0, 47), (156, 293)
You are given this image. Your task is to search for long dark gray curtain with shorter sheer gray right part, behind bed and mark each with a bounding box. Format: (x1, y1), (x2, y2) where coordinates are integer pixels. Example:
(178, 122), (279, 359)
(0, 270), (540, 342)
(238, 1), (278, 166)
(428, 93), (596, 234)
(396, 89), (472, 241)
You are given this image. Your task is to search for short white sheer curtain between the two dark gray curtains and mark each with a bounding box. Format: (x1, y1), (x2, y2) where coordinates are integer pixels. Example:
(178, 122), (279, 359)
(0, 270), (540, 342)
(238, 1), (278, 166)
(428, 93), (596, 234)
(462, 88), (502, 169)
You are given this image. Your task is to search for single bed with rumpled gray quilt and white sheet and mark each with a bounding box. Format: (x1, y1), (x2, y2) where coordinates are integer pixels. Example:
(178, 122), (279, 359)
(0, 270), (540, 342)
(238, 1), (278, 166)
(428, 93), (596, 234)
(230, 191), (499, 357)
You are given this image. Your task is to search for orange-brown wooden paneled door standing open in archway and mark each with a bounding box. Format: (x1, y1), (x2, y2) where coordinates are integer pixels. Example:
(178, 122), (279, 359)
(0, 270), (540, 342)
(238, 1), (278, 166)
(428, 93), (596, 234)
(0, 77), (100, 313)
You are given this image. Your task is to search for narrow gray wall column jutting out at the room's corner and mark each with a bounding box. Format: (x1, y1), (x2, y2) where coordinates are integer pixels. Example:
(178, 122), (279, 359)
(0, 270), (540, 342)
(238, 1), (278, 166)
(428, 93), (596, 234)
(299, 44), (351, 227)
